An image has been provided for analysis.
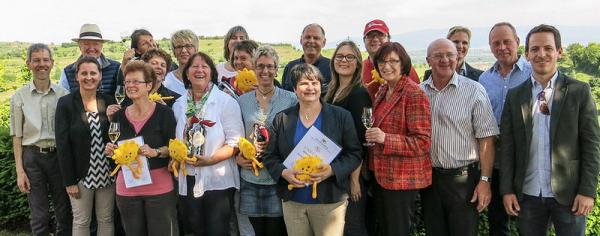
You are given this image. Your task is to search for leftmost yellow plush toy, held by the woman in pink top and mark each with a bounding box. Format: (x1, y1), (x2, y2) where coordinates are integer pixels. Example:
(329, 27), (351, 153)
(110, 140), (142, 179)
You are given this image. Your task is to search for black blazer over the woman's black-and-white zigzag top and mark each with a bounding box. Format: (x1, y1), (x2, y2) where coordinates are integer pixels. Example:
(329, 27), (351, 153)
(55, 90), (116, 186)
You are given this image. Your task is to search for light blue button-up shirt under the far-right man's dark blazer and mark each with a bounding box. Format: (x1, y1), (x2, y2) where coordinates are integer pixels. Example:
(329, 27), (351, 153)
(523, 72), (558, 197)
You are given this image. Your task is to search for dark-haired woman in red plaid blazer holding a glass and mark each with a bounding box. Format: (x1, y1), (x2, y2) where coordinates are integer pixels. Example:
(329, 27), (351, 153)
(365, 42), (431, 235)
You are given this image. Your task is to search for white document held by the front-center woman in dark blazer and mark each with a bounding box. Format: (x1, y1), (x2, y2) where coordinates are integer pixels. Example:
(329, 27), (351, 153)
(283, 126), (342, 168)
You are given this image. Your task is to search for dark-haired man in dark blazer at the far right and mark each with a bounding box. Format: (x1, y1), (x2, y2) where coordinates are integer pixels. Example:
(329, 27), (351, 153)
(500, 25), (600, 236)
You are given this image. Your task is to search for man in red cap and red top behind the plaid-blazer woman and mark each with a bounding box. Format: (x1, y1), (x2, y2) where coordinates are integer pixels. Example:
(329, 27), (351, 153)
(363, 19), (420, 99)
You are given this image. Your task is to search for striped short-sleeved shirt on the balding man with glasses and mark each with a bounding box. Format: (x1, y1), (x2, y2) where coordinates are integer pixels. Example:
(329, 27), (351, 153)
(421, 73), (500, 169)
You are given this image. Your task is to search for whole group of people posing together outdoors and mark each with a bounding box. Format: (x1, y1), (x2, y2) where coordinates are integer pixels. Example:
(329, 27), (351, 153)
(11, 20), (600, 235)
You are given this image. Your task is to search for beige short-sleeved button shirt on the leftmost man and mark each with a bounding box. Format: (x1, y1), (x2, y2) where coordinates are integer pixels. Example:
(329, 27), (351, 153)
(10, 81), (69, 147)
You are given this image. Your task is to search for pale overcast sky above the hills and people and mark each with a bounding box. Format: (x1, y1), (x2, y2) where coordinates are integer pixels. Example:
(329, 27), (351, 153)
(0, 0), (600, 44)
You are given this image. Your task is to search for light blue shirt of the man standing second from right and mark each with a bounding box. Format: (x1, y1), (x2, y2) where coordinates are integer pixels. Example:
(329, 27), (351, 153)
(479, 57), (531, 124)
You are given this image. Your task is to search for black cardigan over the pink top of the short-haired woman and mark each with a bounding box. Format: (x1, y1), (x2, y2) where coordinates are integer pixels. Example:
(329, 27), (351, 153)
(113, 103), (177, 169)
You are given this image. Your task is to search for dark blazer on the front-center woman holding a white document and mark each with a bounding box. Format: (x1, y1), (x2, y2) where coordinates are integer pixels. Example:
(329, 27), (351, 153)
(263, 103), (362, 203)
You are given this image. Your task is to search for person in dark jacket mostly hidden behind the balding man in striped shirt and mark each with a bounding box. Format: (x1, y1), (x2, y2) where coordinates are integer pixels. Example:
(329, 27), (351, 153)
(423, 26), (483, 81)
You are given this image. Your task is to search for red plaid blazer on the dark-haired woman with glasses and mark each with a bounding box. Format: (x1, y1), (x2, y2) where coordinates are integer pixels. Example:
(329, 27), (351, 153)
(369, 77), (431, 190)
